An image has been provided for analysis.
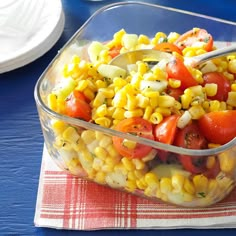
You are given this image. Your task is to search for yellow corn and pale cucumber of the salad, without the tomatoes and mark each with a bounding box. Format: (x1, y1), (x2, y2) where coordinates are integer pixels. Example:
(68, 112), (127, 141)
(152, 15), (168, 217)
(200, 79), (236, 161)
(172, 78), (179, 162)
(47, 28), (236, 206)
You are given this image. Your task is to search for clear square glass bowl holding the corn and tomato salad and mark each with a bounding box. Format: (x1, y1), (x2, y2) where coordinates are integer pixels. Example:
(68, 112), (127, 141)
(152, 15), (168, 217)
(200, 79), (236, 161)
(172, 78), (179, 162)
(35, 2), (236, 207)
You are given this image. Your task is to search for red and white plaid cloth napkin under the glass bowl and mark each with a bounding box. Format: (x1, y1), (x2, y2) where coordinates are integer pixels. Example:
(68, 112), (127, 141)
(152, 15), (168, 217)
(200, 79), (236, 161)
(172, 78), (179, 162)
(35, 149), (236, 230)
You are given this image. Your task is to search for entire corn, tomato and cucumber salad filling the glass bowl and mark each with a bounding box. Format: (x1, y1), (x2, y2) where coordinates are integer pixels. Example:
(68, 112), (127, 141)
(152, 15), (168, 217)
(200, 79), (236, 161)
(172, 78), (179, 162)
(34, 1), (236, 207)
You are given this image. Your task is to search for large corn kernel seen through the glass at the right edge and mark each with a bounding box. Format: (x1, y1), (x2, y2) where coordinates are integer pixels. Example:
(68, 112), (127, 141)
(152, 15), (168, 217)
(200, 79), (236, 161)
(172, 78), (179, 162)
(218, 151), (236, 173)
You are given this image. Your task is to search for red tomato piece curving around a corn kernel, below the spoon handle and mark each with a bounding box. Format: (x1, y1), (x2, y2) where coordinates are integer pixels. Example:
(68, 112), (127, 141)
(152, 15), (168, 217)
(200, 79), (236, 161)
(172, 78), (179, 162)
(203, 72), (231, 101)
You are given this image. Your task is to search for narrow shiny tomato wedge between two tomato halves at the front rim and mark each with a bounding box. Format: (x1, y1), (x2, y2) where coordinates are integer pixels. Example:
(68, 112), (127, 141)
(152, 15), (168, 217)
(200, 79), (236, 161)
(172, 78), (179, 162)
(154, 115), (179, 144)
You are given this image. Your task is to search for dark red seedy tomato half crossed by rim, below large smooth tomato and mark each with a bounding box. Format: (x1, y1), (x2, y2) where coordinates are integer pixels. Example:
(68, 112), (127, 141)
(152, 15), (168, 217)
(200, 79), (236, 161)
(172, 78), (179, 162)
(174, 123), (207, 174)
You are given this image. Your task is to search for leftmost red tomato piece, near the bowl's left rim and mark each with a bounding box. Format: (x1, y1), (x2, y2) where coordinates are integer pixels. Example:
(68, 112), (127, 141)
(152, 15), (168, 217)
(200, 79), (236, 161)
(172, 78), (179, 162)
(65, 90), (92, 121)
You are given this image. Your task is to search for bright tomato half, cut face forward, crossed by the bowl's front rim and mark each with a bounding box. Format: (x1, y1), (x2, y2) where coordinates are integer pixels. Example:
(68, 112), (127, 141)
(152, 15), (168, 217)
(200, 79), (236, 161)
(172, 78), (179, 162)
(112, 117), (154, 158)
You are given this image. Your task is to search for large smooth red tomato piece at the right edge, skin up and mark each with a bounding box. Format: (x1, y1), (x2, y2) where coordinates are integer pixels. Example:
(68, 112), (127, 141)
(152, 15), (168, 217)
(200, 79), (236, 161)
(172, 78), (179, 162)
(198, 110), (236, 145)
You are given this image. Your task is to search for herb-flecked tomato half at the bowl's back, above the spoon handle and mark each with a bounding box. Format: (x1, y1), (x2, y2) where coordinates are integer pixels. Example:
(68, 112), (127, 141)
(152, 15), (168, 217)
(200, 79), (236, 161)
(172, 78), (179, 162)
(175, 28), (213, 52)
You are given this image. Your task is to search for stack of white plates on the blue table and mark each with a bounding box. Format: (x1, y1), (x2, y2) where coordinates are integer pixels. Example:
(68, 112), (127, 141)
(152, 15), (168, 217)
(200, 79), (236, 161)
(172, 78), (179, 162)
(0, 0), (65, 73)
